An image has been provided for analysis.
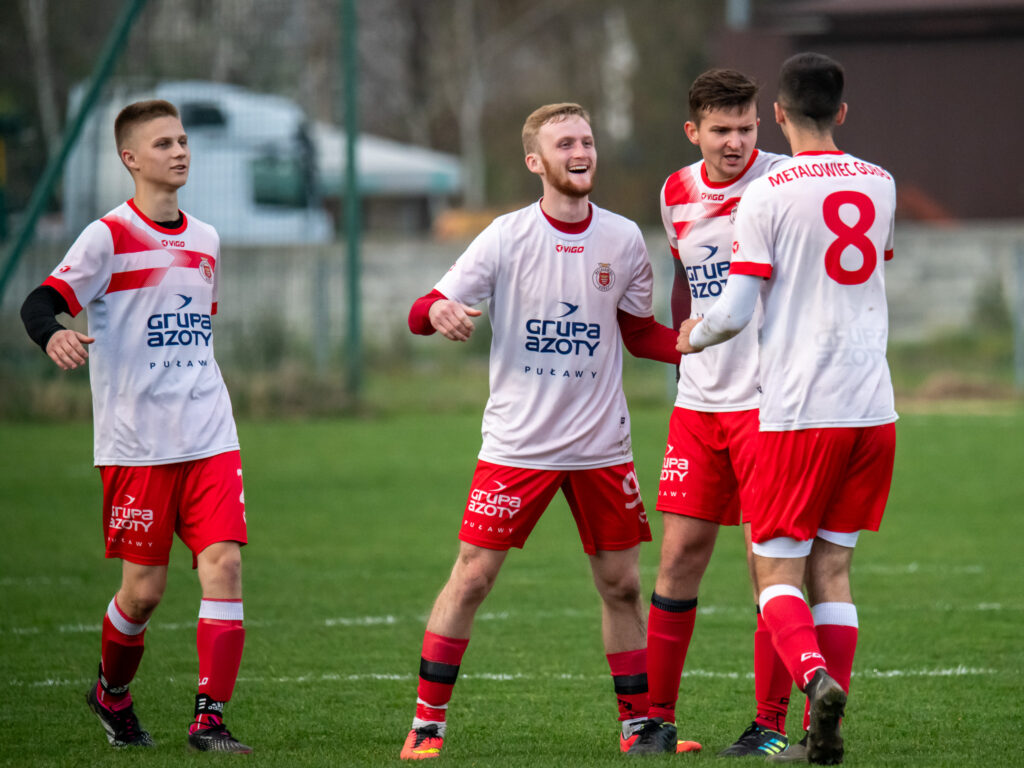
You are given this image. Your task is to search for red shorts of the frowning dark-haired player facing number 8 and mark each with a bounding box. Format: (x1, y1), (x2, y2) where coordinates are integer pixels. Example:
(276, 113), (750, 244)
(657, 408), (758, 525)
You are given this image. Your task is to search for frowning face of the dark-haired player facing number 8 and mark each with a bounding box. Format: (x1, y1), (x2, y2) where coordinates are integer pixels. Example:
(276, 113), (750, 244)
(684, 101), (759, 182)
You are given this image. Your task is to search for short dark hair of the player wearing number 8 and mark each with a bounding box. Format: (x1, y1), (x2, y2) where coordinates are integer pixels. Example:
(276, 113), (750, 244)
(778, 52), (845, 131)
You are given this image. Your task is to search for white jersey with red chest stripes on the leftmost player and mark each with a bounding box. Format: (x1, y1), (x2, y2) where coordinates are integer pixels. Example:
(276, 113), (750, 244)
(43, 201), (239, 466)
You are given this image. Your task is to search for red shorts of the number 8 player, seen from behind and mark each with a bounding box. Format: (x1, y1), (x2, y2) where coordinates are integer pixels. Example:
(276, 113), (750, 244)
(751, 424), (896, 544)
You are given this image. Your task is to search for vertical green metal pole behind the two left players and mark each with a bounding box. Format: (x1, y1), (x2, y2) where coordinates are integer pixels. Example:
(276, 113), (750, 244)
(341, 0), (362, 401)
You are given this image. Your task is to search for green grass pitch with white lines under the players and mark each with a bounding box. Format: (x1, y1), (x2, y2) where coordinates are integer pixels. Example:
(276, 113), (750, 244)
(0, 405), (1024, 768)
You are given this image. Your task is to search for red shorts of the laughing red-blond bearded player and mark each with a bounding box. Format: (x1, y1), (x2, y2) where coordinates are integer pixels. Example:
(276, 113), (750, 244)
(459, 461), (650, 555)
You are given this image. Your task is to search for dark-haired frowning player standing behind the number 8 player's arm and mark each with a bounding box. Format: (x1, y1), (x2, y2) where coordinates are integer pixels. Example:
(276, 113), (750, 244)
(637, 69), (793, 757)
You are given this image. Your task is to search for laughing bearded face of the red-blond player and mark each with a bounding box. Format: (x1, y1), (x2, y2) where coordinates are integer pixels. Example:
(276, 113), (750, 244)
(526, 115), (597, 198)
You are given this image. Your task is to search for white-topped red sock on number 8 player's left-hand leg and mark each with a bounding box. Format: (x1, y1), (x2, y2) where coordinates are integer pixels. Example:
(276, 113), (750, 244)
(761, 584), (825, 690)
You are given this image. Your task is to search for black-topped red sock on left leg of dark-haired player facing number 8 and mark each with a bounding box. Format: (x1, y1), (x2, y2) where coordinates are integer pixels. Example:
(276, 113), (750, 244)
(647, 592), (697, 723)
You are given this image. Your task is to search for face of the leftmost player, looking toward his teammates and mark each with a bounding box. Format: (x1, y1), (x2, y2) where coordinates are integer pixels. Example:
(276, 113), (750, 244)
(121, 116), (191, 189)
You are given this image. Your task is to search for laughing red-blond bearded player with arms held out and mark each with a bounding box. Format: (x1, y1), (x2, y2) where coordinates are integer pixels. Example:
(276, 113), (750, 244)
(401, 103), (692, 760)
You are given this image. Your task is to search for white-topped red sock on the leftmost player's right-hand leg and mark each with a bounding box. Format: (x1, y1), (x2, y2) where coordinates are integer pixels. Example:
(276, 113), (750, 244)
(196, 598), (246, 702)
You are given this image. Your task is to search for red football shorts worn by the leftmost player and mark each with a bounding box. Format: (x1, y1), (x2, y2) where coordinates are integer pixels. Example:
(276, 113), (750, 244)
(99, 451), (248, 567)
